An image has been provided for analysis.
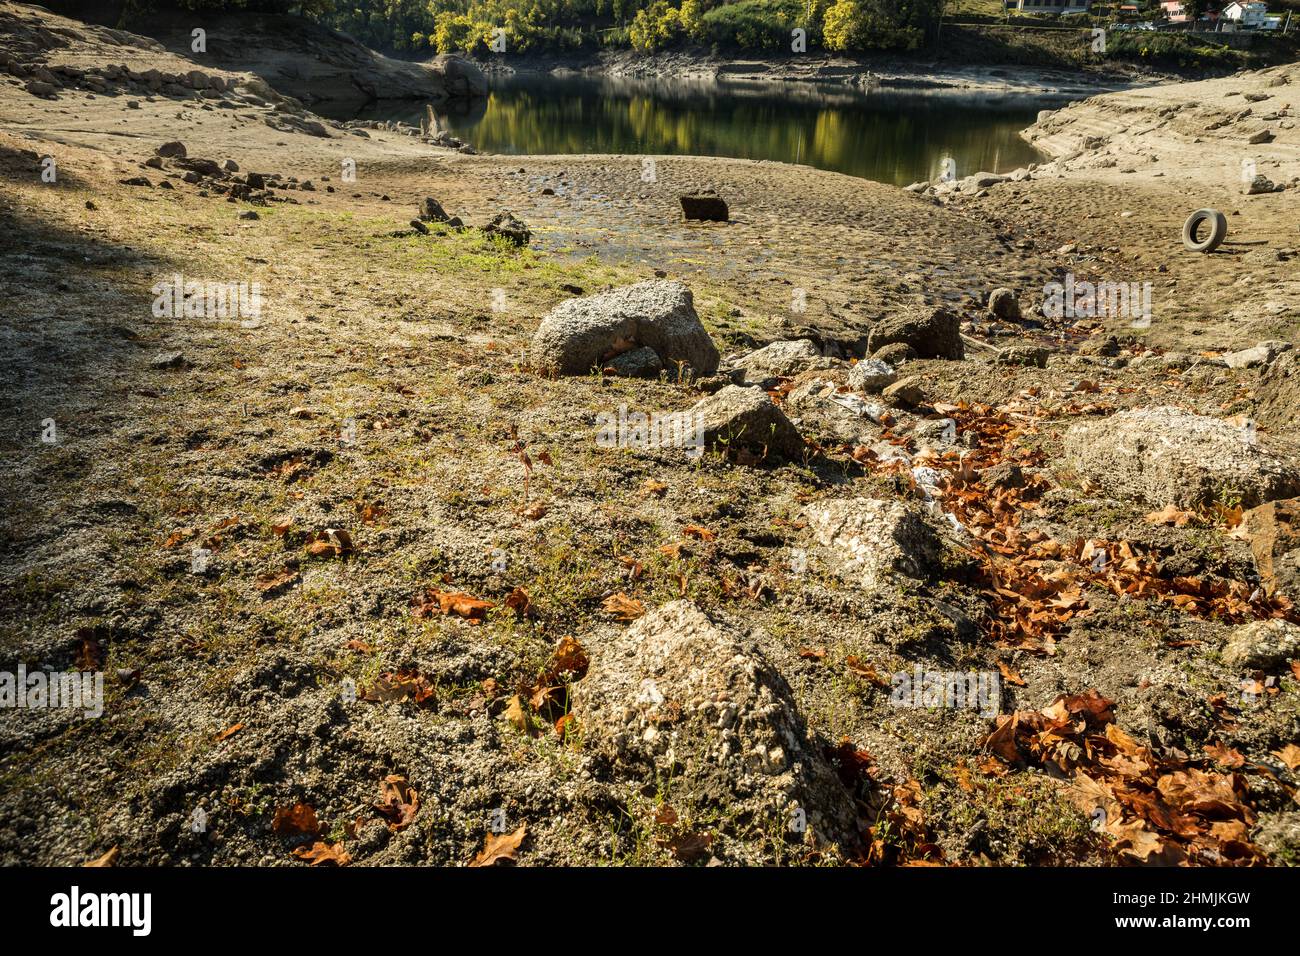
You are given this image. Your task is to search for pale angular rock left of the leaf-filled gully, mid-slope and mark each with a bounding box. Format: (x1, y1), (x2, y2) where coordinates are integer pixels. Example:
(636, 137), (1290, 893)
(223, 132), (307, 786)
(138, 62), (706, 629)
(805, 498), (944, 591)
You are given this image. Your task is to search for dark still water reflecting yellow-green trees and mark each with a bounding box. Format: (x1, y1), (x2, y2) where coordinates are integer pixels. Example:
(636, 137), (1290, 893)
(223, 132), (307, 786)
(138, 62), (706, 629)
(335, 75), (1067, 186)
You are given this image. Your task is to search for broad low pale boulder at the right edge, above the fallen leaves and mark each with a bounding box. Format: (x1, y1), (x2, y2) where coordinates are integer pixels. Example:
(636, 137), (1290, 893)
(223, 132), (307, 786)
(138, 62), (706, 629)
(1063, 406), (1300, 507)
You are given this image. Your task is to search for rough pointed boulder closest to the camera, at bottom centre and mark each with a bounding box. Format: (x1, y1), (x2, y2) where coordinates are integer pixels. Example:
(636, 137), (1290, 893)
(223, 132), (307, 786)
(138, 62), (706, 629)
(573, 601), (855, 845)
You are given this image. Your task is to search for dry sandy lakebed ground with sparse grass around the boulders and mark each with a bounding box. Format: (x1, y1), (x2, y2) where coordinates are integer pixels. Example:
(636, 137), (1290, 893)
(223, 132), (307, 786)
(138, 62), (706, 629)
(0, 0), (1300, 865)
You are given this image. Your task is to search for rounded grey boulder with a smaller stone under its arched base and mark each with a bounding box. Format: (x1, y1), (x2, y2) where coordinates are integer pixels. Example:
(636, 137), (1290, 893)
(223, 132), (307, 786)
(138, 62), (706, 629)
(533, 280), (719, 376)
